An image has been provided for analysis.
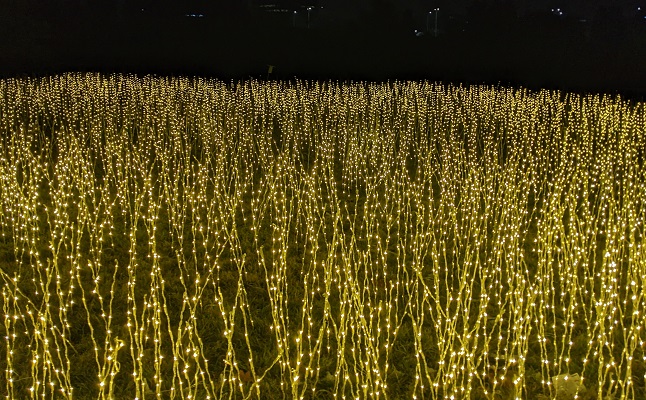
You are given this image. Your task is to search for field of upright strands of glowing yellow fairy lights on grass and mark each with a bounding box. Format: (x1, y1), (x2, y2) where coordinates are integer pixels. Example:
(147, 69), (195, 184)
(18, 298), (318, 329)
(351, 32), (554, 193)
(0, 73), (646, 400)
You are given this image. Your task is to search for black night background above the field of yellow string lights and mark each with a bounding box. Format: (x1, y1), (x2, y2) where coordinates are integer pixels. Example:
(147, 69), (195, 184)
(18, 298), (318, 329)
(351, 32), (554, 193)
(0, 0), (646, 94)
